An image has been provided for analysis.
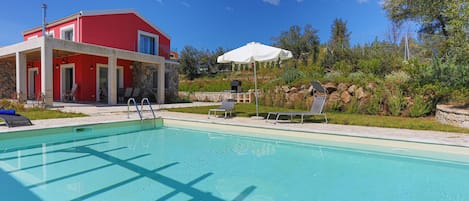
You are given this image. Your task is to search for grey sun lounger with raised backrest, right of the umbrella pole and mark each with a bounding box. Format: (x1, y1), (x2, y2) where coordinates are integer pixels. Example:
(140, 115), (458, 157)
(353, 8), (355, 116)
(266, 96), (327, 124)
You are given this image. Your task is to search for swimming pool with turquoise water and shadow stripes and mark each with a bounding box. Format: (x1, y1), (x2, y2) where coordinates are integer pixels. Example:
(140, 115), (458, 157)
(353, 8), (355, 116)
(0, 121), (469, 201)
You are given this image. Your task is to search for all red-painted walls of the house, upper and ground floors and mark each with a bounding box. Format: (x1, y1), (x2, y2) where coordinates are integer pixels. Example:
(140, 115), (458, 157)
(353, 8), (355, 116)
(23, 13), (170, 102)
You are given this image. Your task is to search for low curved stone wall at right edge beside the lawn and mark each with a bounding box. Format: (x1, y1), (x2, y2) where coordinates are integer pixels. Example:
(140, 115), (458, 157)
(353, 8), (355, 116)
(435, 105), (469, 128)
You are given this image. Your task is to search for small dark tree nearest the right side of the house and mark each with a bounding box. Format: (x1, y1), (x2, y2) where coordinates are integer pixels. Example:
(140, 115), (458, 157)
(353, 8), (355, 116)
(179, 46), (201, 80)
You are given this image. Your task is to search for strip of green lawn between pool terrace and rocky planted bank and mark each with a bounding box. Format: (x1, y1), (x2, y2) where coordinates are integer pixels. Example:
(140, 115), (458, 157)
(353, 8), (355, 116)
(168, 104), (469, 133)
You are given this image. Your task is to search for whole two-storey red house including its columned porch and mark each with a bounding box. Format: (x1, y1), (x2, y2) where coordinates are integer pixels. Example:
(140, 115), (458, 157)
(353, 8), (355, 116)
(0, 10), (177, 105)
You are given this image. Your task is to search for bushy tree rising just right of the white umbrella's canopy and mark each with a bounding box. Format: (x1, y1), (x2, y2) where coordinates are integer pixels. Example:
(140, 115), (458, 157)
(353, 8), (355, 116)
(273, 24), (319, 67)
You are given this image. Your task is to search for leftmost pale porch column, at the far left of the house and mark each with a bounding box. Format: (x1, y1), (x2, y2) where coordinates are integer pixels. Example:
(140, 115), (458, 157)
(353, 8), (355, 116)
(16, 52), (27, 101)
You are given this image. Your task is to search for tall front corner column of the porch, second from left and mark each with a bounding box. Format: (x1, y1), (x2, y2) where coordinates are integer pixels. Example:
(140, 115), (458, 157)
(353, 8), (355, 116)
(41, 40), (54, 106)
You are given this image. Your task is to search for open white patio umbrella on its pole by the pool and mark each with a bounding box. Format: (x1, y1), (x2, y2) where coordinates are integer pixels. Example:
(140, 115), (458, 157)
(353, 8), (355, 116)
(217, 42), (293, 118)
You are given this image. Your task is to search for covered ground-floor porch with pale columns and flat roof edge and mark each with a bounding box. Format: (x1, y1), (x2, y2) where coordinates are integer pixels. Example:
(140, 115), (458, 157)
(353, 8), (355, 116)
(0, 37), (165, 106)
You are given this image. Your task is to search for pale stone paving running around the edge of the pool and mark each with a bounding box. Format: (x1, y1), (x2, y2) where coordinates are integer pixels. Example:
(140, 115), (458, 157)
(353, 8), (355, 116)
(0, 102), (469, 147)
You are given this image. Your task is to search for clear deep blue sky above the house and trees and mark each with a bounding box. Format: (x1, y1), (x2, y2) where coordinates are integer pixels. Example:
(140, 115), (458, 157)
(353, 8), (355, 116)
(0, 0), (396, 51)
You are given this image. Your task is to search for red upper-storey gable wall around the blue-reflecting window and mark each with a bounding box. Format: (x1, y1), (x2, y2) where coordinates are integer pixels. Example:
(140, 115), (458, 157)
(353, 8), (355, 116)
(80, 13), (170, 59)
